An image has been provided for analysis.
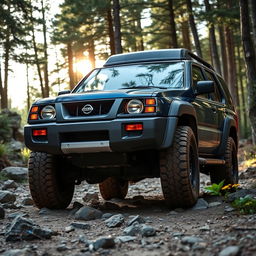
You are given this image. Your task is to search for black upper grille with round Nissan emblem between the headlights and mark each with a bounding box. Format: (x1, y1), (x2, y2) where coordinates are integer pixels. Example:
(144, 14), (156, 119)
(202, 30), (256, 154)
(63, 100), (114, 116)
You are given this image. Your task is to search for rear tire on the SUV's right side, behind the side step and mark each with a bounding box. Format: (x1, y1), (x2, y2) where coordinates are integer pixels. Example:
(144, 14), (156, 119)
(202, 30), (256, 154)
(210, 137), (238, 185)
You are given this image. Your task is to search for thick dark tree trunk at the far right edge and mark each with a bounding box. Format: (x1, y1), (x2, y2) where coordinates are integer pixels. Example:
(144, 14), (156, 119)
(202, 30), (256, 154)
(239, 0), (256, 144)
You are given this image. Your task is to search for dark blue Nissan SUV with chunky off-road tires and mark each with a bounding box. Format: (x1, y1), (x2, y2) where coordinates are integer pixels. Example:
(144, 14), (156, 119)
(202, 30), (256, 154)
(25, 49), (238, 208)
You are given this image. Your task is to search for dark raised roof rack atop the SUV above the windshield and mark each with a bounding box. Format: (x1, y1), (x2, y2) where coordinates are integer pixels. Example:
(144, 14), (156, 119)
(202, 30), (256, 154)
(104, 48), (213, 69)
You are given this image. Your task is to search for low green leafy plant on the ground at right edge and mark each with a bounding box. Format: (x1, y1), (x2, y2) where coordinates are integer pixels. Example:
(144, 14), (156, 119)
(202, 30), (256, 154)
(232, 195), (256, 214)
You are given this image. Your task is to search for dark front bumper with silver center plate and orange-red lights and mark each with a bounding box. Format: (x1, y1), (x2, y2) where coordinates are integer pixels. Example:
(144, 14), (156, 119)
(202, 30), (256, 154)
(24, 117), (178, 154)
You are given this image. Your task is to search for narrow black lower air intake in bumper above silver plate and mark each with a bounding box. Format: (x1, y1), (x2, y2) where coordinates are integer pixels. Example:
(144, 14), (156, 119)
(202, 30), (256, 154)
(60, 131), (109, 142)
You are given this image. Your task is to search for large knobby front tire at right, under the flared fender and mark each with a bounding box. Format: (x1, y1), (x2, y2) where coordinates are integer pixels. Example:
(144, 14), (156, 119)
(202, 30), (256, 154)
(160, 126), (200, 208)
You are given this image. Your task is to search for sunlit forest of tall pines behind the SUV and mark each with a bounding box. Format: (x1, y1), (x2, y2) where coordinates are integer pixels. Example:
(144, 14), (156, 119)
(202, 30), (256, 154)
(0, 0), (256, 143)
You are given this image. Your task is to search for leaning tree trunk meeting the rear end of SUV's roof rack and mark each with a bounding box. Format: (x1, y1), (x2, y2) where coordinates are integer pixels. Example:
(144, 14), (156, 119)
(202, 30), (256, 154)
(204, 0), (221, 74)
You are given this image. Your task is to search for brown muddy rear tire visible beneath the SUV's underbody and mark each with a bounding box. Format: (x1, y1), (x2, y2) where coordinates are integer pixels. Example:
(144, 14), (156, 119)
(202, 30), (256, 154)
(99, 177), (129, 200)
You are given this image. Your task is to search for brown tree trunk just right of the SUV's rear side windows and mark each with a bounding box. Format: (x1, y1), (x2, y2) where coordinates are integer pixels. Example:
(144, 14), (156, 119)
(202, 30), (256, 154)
(225, 26), (239, 106)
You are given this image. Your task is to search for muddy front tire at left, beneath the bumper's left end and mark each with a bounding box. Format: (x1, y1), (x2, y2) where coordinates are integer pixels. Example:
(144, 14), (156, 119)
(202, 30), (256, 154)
(28, 152), (75, 209)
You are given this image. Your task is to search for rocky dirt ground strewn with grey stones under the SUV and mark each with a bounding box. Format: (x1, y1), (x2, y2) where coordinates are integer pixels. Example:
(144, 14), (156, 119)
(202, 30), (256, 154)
(0, 158), (256, 256)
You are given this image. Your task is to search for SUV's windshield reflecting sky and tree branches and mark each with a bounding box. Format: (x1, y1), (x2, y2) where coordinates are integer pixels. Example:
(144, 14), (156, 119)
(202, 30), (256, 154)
(75, 62), (184, 93)
